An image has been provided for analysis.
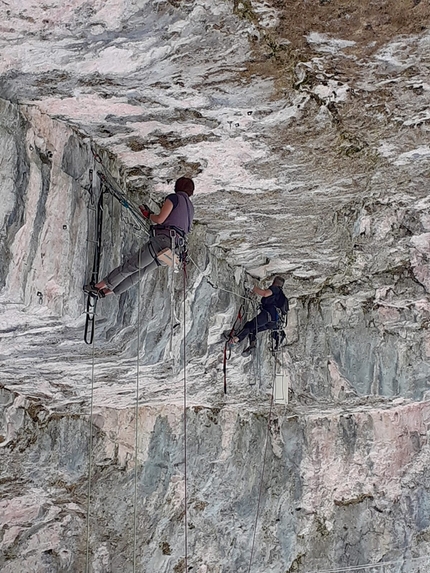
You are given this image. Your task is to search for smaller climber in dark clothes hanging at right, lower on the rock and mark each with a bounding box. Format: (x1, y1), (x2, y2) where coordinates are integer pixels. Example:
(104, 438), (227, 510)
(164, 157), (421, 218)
(230, 276), (285, 354)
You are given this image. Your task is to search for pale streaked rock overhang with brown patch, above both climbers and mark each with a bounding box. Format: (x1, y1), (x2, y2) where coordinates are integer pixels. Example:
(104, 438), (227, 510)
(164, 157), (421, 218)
(0, 0), (430, 408)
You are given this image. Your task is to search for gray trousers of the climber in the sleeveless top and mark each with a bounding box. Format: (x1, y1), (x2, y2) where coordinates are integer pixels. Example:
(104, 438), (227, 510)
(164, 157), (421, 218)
(103, 235), (172, 295)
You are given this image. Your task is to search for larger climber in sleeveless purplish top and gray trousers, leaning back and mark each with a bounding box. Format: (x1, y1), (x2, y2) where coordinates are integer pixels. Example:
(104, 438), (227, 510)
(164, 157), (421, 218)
(84, 177), (194, 298)
